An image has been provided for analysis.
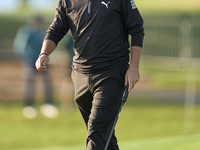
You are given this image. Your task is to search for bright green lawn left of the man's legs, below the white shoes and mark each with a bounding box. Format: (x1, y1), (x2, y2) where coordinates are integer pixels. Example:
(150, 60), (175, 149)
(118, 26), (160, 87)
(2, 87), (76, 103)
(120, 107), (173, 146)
(0, 104), (86, 150)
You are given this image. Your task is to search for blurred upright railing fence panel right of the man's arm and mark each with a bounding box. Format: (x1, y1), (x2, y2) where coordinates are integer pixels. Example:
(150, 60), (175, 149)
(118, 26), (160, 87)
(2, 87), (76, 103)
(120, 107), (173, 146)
(142, 16), (200, 67)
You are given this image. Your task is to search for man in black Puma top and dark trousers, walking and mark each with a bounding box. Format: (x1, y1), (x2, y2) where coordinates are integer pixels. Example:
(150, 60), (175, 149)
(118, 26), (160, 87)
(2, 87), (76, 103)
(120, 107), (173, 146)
(36, 0), (144, 150)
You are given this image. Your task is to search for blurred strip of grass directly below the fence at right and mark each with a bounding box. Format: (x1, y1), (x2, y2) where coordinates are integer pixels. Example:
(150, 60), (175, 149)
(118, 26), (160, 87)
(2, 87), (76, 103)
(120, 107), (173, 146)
(140, 65), (200, 90)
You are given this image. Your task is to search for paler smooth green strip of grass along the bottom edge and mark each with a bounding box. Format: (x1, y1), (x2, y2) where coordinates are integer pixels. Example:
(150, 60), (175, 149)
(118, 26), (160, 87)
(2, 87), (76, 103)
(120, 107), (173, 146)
(18, 134), (200, 150)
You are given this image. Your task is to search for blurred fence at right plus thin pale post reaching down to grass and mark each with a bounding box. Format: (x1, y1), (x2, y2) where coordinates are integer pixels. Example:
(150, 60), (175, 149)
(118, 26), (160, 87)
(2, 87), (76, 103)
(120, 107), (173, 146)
(142, 16), (200, 132)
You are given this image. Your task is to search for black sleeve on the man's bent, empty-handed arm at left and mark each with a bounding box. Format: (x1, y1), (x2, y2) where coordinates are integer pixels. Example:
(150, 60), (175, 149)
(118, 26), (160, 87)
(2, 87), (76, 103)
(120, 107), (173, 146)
(45, 0), (69, 45)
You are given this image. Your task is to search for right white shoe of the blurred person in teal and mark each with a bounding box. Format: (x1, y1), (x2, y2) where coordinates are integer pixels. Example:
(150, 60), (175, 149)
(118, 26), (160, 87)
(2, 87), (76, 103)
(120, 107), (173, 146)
(40, 104), (58, 118)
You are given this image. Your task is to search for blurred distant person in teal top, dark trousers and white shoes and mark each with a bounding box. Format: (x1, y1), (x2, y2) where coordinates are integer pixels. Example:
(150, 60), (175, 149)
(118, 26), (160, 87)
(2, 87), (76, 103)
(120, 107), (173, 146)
(14, 17), (58, 119)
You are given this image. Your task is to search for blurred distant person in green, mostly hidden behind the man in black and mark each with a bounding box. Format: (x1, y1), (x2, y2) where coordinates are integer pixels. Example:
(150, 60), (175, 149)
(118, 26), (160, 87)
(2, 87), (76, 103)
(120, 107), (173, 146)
(60, 33), (74, 113)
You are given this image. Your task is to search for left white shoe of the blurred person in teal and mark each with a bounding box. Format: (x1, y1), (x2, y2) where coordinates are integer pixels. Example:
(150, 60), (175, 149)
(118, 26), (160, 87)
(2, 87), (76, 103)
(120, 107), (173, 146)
(22, 106), (37, 119)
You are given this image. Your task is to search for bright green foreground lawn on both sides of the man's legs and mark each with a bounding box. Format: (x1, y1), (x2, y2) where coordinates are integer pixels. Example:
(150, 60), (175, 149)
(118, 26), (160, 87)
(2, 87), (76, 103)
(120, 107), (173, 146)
(0, 95), (200, 150)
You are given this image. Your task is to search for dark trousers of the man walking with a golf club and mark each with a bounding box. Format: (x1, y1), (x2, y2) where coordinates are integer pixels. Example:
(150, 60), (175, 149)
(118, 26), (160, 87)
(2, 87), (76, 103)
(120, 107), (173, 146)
(72, 64), (128, 150)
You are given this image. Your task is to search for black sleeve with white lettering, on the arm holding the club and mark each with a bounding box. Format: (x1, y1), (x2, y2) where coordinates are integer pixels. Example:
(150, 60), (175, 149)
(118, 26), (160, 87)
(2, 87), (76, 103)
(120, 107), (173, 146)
(121, 0), (144, 47)
